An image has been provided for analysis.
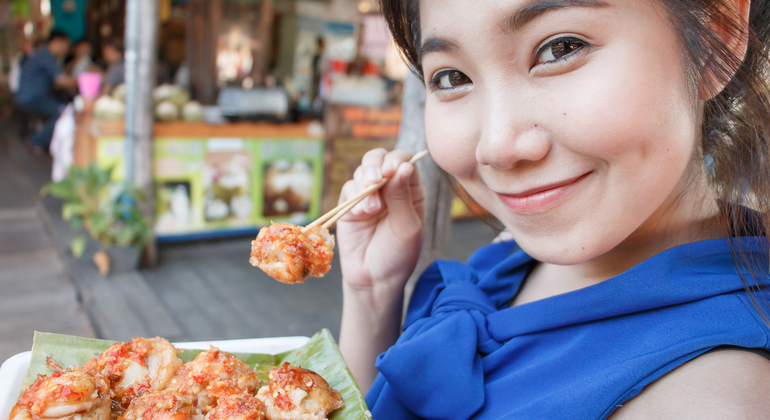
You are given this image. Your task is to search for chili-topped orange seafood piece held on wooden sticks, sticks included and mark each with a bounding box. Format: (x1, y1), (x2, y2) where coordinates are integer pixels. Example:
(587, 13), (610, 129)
(249, 150), (428, 284)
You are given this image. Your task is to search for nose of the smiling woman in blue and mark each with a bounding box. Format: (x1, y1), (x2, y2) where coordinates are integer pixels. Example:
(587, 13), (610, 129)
(476, 93), (551, 170)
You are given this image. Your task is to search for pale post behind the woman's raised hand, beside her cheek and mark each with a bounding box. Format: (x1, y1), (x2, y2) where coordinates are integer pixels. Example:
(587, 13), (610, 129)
(396, 72), (454, 310)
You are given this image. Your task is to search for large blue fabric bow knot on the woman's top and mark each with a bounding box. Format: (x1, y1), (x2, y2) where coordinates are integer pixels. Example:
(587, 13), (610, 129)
(373, 261), (502, 420)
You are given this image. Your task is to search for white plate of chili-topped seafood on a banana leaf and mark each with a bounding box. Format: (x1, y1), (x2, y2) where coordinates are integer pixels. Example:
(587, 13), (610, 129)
(0, 330), (371, 420)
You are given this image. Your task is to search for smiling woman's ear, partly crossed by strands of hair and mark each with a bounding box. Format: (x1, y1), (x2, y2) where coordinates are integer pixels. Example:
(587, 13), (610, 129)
(699, 0), (751, 101)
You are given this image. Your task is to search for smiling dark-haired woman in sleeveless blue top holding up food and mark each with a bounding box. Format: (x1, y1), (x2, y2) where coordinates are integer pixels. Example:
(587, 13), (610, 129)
(337, 0), (770, 419)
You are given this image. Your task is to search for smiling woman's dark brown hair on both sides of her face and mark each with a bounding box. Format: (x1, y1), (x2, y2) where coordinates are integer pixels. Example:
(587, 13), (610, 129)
(380, 0), (770, 308)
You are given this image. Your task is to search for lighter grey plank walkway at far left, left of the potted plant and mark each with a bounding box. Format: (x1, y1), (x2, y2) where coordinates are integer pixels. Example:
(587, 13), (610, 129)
(0, 127), (95, 361)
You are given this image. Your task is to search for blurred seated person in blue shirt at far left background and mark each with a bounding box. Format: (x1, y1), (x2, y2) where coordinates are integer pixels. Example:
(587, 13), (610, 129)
(14, 30), (77, 155)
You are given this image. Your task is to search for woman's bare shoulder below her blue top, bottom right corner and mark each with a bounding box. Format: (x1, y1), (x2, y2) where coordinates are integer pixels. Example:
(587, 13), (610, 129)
(610, 350), (770, 420)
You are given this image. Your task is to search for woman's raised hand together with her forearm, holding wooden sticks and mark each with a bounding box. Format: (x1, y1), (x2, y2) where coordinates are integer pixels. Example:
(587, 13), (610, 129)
(337, 149), (425, 393)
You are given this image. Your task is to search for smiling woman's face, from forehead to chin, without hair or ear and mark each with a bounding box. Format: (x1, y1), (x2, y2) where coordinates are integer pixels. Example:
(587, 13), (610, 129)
(420, 0), (699, 264)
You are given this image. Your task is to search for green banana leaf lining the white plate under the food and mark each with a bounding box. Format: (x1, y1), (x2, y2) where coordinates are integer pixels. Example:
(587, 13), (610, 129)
(22, 329), (372, 420)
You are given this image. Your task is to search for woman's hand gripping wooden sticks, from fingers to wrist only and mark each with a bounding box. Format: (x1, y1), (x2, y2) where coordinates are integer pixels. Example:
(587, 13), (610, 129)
(337, 149), (425, 297)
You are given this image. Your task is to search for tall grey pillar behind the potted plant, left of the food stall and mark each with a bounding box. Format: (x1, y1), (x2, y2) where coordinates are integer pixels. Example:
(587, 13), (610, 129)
(125, 0), (158, 264)
